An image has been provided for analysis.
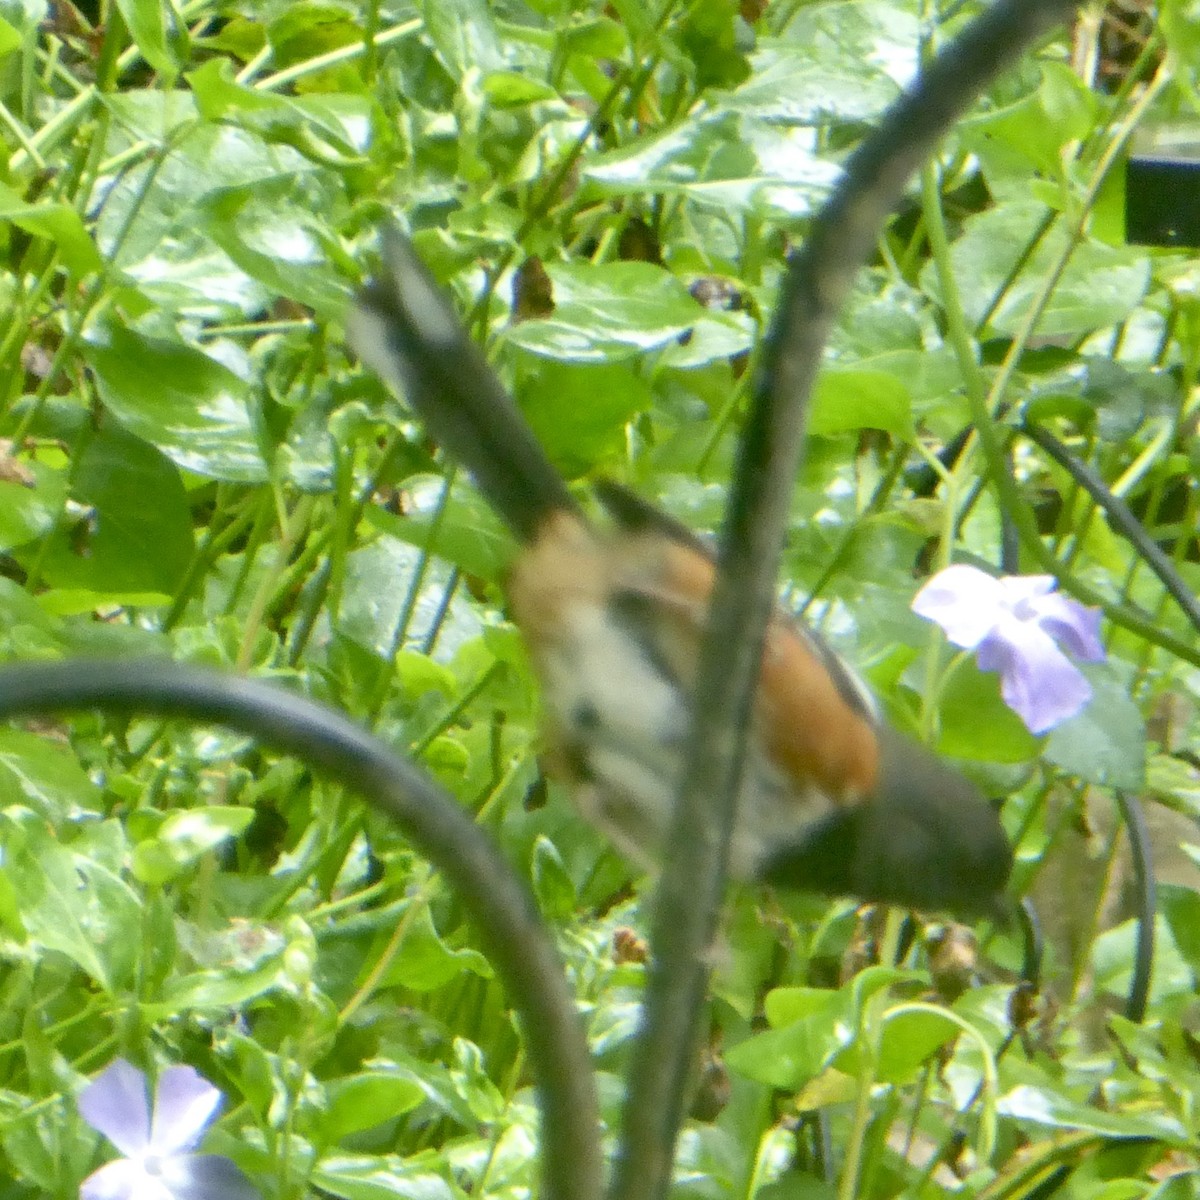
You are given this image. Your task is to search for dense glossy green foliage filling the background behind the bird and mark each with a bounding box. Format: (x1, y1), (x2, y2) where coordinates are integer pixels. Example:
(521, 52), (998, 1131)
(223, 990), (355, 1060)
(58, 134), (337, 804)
(0, 0), (1200, 1200)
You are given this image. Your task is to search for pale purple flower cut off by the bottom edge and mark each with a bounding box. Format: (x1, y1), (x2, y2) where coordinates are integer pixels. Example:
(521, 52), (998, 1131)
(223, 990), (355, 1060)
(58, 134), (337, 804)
(78, 1058), (259, 1200)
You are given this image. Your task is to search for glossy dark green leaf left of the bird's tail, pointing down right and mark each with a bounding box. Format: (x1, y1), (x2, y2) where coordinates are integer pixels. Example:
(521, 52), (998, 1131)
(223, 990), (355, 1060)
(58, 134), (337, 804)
(82, 325), (268, 484)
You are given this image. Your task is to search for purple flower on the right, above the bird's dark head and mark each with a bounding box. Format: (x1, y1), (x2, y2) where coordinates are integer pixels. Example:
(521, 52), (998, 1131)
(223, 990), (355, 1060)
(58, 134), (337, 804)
(912, 563), (1104, 733)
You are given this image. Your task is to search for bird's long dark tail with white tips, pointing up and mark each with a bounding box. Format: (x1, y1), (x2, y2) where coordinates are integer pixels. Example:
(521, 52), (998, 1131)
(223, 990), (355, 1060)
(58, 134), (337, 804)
(347, 228), (576, 541)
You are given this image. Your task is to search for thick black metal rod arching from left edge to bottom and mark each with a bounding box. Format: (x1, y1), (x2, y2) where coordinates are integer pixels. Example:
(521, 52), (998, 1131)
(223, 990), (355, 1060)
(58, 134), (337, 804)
(0, 659), (601, 1200)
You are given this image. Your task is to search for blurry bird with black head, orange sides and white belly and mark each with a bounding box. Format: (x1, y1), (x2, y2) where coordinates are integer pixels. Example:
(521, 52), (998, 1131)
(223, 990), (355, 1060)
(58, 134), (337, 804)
(347, 228), (1013, 917)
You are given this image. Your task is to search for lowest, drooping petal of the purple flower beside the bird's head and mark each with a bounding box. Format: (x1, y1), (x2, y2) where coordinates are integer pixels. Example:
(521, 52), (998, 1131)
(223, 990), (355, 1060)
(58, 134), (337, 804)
(977, 618), (1092, 733)
